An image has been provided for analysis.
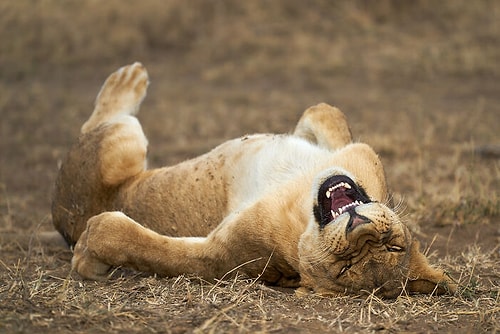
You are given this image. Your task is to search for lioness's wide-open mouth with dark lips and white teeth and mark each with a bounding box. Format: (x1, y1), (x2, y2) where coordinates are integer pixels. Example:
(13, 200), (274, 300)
(316, 175), (371, 226)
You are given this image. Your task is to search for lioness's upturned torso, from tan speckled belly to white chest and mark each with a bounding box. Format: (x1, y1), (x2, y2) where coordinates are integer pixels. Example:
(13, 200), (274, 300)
(113, 135), (329, 236)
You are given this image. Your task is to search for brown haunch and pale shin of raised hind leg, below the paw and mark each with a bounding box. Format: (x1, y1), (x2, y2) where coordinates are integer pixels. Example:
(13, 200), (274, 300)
(52, 115), (147, 245)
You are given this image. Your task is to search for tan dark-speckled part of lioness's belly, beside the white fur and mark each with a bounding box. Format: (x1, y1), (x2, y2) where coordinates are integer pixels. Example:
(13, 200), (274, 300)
(114, 155), (227, 237)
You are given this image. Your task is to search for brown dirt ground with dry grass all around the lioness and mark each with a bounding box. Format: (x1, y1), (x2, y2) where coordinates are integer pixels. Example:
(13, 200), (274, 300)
(0, 0), (500, 333)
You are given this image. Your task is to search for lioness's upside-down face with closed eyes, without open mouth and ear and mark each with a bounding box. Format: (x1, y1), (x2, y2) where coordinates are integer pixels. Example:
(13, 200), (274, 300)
(299, 202), (412, 297)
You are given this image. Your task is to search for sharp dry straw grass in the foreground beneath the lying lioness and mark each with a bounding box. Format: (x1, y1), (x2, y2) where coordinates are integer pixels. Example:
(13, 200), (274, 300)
(1, 241), (500, 332)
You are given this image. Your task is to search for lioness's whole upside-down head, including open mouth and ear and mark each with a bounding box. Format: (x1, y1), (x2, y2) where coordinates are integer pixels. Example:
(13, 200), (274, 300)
(299, 171), (455, 297)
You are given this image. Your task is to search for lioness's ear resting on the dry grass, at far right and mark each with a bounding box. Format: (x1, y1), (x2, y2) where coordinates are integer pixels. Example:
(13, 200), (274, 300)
(406, 241), (457, 294)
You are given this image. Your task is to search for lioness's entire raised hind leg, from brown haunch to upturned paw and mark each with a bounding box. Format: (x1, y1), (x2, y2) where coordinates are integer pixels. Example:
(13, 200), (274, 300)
(52, 63), (148, 245)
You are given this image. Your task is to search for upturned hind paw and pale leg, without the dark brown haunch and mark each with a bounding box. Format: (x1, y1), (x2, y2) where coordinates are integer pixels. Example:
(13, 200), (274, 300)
(82, 63), (149, 186)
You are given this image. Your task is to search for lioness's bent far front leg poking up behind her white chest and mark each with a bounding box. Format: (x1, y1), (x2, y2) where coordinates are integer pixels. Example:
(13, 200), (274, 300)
(293, 103), (352, 150)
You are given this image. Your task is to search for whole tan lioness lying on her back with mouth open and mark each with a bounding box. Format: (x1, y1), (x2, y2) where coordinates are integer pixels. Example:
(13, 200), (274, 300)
(52, 63), (456, 298)
